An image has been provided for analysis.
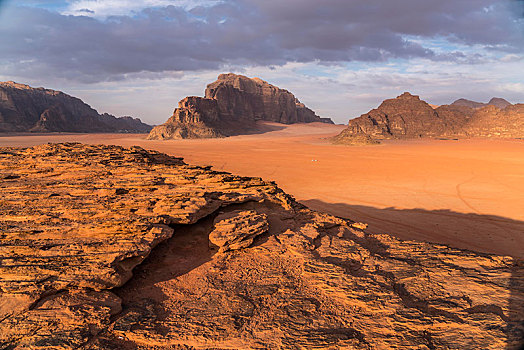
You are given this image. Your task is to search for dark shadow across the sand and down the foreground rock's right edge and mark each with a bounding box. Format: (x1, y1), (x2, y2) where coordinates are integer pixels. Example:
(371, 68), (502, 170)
(301, 199), (524, 350)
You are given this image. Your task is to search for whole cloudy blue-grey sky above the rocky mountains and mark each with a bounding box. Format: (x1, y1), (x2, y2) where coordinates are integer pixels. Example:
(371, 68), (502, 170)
(0, 0), (524, 124)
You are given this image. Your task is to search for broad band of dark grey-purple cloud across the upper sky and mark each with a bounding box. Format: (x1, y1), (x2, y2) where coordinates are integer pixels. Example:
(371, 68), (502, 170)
(0, 0), (523, 81)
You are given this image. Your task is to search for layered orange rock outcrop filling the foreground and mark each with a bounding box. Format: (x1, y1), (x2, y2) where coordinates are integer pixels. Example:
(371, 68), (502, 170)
(0, 144), (524, 349)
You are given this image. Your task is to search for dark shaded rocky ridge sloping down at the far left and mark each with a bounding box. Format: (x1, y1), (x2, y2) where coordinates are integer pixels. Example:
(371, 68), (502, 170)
(0, 81), (152, 133)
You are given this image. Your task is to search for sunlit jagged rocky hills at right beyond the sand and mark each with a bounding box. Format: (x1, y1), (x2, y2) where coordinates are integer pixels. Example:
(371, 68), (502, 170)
(333, 92), (524, 144)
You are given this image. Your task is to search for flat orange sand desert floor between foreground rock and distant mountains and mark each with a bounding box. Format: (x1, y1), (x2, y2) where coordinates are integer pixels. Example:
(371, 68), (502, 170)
(0, 123), (524, 257)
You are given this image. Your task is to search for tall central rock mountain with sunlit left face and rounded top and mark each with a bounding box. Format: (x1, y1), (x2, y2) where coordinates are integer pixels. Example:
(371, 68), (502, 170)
(148, 73), (333, 140)
